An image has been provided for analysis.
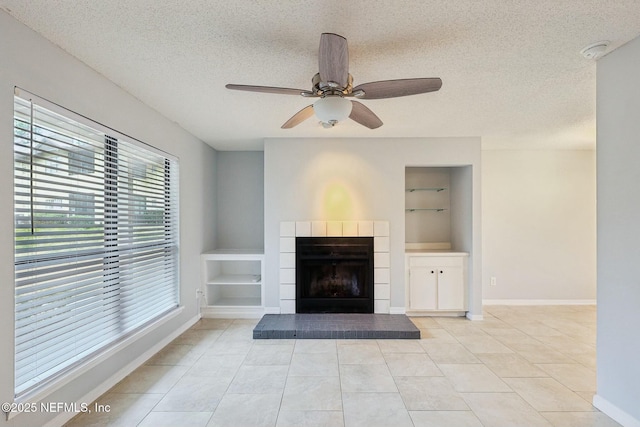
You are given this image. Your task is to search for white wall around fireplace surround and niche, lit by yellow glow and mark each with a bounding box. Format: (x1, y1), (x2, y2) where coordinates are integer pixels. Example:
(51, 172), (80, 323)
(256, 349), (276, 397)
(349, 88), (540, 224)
(264, 138), (482, 315)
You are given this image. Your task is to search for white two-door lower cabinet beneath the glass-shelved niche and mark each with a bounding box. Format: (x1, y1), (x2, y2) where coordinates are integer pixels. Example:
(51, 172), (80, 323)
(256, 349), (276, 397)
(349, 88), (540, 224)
(406, 252), (468, 315)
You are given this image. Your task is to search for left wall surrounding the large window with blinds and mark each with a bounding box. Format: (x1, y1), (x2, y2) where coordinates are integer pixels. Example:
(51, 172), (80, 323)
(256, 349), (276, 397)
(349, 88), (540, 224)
(0, 12), (215, 426)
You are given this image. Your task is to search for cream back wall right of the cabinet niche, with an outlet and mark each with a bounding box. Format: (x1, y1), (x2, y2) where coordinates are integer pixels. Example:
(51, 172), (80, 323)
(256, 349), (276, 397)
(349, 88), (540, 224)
(482, 150), (596, 302)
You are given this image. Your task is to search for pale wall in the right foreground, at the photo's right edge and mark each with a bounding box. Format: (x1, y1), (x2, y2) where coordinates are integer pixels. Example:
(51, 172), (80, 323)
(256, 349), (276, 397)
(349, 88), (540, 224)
(594, 38), (640, 427)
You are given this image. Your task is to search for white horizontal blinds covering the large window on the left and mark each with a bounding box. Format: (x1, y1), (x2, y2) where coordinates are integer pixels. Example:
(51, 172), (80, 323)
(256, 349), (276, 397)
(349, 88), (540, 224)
(14, 93), (178, 396)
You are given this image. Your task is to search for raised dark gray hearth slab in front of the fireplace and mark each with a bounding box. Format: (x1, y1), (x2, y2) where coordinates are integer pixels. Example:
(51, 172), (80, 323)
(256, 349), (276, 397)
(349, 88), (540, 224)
(253, 313), (420, 339)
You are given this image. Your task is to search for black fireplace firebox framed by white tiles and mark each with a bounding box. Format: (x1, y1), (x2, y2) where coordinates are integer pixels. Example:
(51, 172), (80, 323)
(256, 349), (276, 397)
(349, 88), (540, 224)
(296, 237), (374, 313)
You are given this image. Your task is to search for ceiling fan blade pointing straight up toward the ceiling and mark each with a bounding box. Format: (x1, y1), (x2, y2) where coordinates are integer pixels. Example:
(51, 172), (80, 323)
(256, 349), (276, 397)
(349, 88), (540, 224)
(318, 33), (349, 88)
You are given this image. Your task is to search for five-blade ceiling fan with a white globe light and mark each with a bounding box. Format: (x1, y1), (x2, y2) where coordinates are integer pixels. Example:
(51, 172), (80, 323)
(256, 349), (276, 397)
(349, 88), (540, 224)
(225, 33), (442, 129)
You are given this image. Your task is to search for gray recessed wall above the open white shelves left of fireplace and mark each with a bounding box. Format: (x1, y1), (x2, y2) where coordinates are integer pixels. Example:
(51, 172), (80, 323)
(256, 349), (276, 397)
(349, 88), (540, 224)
(215, 151), (264, 249)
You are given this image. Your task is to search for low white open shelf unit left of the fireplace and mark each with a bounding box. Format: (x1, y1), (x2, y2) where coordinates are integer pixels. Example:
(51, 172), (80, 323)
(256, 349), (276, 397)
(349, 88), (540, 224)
(201, 249), (264, 317)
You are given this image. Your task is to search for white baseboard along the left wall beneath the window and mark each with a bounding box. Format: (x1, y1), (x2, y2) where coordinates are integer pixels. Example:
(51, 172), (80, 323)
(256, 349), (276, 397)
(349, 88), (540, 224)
(44, 315), (200, 427)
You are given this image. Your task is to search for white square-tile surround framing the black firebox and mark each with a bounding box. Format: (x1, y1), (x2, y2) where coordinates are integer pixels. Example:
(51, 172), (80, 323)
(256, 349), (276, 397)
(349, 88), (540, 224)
(280, 221), (391, 314)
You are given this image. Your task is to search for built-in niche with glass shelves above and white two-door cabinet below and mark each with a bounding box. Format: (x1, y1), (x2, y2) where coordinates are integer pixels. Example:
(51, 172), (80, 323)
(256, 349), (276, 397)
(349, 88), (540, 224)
(405, 166), (472, 316)
